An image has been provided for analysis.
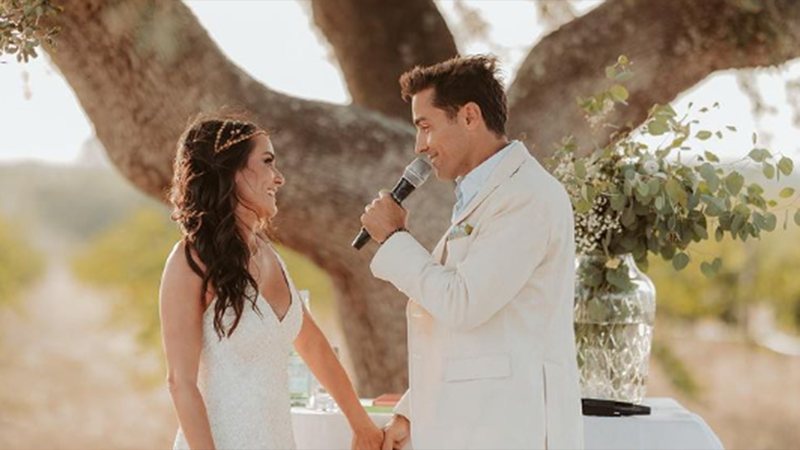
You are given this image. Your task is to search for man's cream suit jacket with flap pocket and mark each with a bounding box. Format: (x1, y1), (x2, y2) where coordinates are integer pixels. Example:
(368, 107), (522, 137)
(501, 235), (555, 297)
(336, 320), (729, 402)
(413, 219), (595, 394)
(371, 142), (583, 450)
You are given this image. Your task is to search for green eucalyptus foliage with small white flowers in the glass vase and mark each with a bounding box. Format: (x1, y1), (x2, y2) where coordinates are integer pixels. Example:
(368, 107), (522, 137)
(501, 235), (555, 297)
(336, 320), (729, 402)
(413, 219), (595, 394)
(550, 56), (800, 292)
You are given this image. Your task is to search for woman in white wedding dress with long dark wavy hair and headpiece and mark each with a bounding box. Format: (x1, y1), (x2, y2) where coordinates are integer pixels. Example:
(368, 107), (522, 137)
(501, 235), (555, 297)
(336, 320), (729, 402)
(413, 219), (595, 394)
(160, 118), (383, 449)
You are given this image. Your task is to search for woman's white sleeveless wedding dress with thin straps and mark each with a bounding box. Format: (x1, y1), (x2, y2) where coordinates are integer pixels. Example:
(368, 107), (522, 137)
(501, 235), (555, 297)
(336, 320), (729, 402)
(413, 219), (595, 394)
(173, 253), (303, 450)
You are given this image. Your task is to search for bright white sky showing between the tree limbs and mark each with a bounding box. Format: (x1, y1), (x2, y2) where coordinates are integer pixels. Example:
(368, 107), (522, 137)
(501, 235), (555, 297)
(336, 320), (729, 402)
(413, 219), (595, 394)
(0, 0), (800, 164)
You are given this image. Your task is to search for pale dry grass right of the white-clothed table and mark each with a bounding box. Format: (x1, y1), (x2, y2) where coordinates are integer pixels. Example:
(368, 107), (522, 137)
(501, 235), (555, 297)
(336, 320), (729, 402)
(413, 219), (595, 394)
(647, 327), (800, 450)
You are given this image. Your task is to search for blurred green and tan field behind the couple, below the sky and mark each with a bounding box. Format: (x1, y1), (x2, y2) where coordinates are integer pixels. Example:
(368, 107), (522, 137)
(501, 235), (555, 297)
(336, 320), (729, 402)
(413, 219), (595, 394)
(0, 146), (800, 449)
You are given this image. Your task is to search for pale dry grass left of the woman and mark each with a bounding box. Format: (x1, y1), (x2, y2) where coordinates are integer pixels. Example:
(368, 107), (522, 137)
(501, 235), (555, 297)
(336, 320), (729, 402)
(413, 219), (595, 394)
(0, 261), (176, 449)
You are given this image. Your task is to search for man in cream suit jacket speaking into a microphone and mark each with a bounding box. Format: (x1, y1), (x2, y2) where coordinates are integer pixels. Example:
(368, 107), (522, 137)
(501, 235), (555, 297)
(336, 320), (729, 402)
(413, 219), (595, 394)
(361, 56), (583, 450)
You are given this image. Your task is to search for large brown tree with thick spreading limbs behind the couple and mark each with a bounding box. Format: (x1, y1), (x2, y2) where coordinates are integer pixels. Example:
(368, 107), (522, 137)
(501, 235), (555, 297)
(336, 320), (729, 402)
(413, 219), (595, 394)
(31, 0), (800, 395)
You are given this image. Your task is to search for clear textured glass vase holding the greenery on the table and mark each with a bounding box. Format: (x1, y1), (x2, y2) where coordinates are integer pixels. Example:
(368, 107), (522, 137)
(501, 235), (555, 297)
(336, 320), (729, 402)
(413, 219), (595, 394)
(575, 254), (656, 404)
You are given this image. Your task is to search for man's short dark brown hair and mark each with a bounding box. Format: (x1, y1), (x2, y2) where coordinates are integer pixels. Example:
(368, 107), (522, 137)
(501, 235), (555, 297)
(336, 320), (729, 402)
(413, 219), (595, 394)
(400, 55), (508, 136)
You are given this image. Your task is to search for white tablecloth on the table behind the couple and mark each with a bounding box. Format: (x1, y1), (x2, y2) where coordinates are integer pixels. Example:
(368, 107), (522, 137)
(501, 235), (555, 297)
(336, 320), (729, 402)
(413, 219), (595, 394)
(292, 398), (723, 450)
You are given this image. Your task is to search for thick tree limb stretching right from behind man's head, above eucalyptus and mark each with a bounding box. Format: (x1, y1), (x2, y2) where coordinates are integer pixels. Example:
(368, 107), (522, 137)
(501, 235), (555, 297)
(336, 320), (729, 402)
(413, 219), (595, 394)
(508, 0), (800, 158)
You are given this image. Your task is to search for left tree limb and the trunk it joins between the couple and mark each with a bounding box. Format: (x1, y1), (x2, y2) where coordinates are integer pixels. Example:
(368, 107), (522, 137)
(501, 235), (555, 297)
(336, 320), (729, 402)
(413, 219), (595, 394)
(47, 0), (452, 395)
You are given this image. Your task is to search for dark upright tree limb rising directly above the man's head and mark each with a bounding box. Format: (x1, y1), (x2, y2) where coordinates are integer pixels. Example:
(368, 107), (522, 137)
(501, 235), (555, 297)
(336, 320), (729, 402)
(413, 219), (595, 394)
(311, 0), (458, 120)
